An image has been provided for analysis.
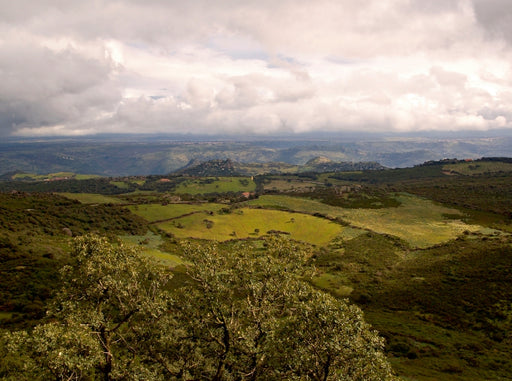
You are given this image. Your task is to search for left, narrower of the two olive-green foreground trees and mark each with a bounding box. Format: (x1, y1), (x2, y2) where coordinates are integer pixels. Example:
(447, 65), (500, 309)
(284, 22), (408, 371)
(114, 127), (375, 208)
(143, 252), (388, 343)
(9, 236), (169, 380)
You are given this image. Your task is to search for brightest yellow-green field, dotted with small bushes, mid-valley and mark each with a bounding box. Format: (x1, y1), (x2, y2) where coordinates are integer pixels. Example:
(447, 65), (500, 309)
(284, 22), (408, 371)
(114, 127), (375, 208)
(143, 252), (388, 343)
(158, 208), (345, 245)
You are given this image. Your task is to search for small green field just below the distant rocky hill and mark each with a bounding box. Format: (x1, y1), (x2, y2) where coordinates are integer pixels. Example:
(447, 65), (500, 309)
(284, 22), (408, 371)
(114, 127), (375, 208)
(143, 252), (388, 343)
(175, 177), (256, 194)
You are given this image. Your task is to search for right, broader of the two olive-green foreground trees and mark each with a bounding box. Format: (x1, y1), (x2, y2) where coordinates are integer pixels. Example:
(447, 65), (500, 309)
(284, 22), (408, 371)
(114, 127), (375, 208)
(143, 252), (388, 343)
(155, 238), (394, 380)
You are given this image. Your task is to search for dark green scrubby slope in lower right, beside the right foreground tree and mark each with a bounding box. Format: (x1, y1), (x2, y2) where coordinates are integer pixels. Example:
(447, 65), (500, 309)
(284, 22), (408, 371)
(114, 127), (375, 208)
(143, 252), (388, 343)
(314, 233), (512, 380)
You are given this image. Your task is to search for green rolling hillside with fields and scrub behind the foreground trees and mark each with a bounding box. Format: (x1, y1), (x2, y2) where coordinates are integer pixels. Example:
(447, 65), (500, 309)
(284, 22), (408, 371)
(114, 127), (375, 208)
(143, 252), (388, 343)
(0, 157), (512, 381)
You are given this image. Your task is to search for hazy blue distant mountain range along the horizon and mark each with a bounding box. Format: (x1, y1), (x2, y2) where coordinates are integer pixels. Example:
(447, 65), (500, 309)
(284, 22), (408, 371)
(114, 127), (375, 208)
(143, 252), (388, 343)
(0, 135), (512, 176)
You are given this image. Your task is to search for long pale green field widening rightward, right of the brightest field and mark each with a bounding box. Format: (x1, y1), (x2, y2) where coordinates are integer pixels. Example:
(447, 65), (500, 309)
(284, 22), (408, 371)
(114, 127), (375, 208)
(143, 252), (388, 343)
(248, 195), (492, 248)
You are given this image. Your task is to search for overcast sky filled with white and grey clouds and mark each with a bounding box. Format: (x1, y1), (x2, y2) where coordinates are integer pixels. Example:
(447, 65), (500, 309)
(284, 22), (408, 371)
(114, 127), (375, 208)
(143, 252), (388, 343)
(0, 0), (512, 136)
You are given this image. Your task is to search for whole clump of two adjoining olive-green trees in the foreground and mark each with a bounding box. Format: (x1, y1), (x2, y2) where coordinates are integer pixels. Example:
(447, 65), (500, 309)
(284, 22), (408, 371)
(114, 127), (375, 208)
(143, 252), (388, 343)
(8, 233), (394, 381)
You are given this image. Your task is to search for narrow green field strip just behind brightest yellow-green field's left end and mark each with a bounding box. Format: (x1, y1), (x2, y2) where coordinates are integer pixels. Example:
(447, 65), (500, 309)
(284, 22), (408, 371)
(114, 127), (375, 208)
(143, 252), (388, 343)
(128, 203), (226, 222)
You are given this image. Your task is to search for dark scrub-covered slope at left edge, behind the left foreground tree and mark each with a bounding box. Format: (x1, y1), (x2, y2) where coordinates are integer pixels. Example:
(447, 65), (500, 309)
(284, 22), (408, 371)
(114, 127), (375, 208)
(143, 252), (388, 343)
(0, 193), (147, 326)
